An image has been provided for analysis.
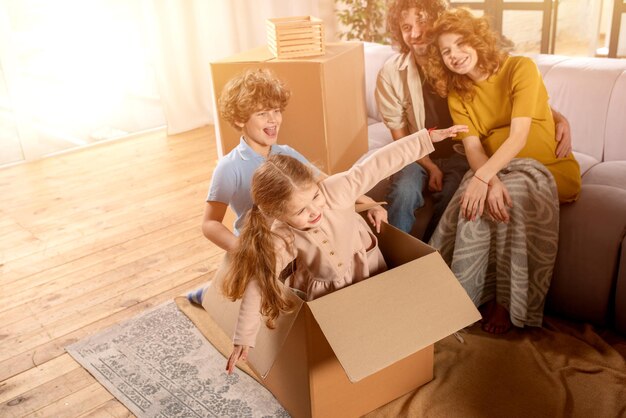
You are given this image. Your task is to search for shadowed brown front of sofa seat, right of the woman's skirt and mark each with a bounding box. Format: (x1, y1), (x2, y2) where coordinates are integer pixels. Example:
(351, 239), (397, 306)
(547, 184), (626, 325)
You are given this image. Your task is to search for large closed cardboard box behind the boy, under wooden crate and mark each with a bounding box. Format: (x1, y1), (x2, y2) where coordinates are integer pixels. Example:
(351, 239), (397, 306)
(211, 42), (368, 174)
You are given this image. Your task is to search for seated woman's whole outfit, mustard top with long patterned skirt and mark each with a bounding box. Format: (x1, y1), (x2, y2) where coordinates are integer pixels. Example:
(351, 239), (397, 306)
(430, 57), (581, 327)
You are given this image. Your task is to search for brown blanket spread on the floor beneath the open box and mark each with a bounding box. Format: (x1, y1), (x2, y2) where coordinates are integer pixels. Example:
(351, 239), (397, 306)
(176, 297), (626, 418)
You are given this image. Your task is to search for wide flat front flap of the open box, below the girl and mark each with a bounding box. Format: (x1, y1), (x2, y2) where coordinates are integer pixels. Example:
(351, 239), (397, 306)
(308, 252), (480, 382)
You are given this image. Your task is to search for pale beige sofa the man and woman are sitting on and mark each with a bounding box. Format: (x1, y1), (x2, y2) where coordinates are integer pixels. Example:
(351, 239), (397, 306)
(364, 43), (626, 333)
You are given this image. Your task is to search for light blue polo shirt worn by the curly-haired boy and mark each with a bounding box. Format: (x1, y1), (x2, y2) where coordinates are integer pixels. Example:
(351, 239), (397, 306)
(206, 137), (318, 235)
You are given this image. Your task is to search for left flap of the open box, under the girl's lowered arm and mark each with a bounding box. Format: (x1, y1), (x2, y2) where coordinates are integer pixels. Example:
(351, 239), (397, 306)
(202, 257), (304, 378)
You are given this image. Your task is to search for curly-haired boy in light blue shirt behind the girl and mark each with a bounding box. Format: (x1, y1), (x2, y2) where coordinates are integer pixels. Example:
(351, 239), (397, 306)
(202, 69), (387, 251)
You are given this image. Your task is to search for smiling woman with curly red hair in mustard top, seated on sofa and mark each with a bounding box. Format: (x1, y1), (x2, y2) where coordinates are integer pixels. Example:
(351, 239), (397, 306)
(426, 9), (581, 333)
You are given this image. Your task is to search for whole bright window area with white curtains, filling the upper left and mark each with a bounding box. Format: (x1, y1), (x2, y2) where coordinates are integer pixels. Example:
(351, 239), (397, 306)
(0, 0), (334, 165)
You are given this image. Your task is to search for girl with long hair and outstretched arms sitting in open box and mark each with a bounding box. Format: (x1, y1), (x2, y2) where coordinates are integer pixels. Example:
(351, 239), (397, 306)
(222, 126), (465, 373)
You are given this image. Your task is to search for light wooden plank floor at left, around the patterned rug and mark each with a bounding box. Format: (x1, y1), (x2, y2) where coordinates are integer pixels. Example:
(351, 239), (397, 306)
(0, 127), (222, 417)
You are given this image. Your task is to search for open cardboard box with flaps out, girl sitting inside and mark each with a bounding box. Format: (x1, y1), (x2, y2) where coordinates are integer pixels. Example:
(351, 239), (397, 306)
(203, 220), (480, 418)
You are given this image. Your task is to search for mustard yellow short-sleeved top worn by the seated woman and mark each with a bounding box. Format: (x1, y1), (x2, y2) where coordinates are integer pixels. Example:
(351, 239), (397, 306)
(448, 56), (581, 203)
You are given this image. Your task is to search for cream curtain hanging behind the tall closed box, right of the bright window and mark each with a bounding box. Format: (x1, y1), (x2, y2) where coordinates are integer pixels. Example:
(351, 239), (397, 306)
(143, 0), (320, 134)
